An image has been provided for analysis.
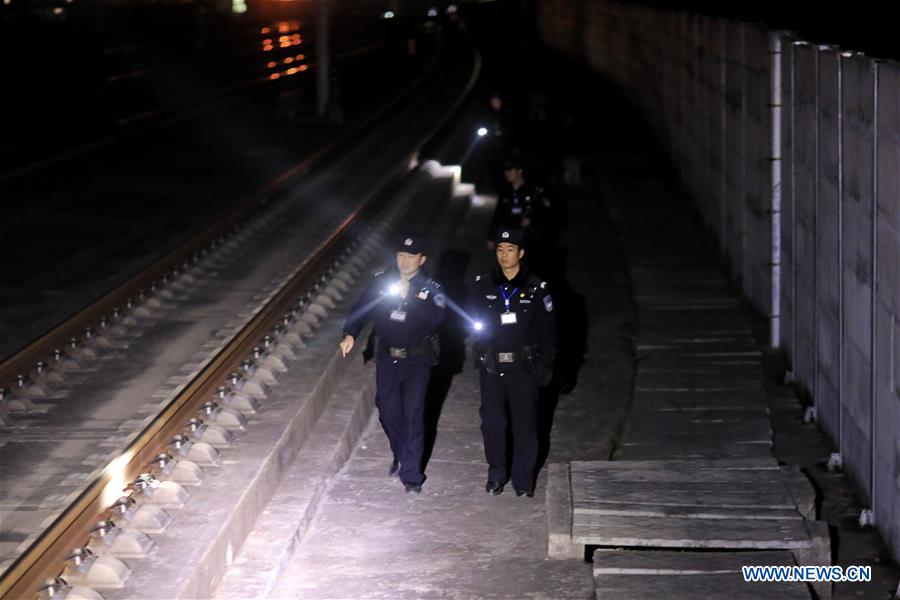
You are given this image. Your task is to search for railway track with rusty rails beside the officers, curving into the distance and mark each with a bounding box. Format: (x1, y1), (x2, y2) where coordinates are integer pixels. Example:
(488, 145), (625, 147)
(0, 34), (480, 598)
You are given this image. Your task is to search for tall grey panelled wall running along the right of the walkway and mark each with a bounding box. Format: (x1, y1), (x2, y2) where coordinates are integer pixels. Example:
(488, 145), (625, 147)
(537, 0), (900, 557)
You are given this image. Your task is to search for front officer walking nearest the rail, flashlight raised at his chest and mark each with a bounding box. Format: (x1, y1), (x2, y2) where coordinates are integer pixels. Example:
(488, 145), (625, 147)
(340, 236), (444, 494)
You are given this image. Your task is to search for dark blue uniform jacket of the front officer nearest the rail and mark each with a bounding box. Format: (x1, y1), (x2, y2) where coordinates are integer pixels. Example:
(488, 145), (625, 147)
(344, 268), (444, 352)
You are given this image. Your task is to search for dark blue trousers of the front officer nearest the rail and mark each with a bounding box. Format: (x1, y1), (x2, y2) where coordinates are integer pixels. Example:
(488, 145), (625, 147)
(375, 354), (431, 484)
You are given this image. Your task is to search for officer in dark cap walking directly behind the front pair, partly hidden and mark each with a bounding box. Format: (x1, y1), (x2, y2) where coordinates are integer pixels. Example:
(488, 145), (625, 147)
(487, 156), (555, 259)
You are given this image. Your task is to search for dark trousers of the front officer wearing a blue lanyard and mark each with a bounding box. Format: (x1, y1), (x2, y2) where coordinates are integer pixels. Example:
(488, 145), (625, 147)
(480, 365), (538, 491)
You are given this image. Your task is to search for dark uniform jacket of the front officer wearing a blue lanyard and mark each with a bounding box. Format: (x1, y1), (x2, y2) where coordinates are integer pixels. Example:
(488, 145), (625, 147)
(468, 266), (556, 374)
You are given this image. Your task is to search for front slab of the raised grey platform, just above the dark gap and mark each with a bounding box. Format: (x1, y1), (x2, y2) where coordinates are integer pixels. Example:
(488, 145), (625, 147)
(572, 513), (813, 550)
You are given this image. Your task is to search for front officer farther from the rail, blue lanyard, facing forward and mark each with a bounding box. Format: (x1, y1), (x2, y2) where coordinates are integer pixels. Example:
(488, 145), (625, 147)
(468, 229), (556, 497)
